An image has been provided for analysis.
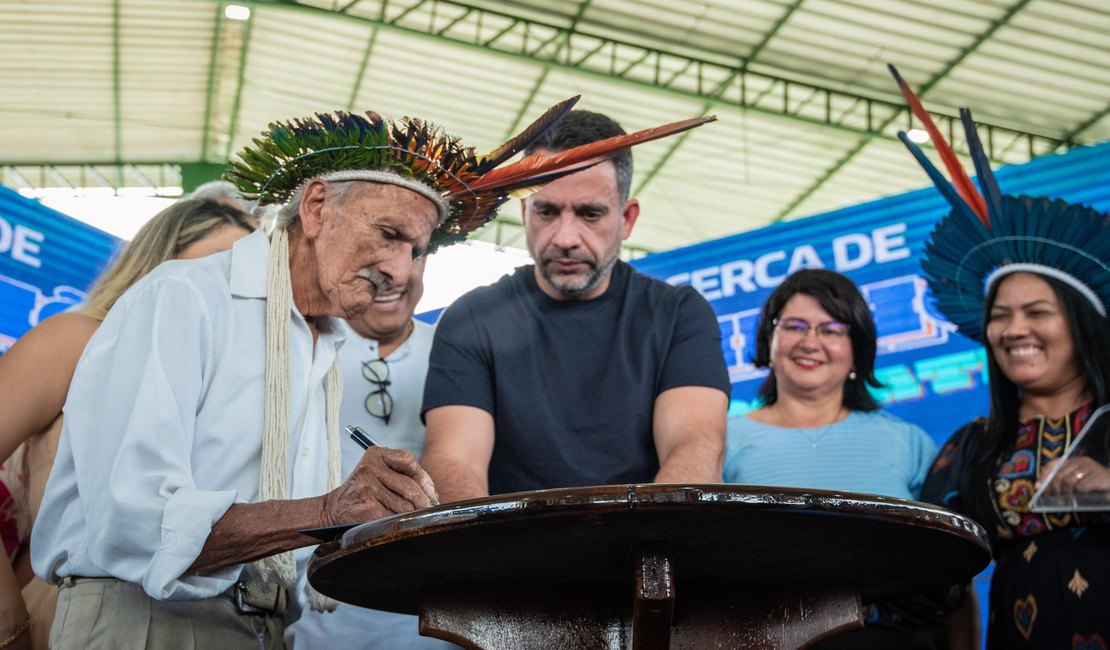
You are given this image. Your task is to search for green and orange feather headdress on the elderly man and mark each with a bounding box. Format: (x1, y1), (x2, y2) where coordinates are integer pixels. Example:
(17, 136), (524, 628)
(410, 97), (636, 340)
(225, 97), (716, 253)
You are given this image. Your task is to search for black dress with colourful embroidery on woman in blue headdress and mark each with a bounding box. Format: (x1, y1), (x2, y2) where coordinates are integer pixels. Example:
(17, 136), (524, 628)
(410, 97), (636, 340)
(921, 406), (1110, 650)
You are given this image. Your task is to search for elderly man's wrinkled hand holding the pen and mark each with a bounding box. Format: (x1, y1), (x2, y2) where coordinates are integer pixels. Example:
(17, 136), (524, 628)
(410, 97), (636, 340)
(324, 447), (440, 526)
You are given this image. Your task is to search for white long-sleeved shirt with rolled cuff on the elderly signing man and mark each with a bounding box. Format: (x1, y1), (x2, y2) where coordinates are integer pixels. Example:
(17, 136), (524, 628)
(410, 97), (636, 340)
(31, 233), (343, 600)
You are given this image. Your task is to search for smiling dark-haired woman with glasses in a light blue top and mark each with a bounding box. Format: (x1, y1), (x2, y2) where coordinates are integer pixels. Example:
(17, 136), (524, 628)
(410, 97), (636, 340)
(724, 270), (945, 649)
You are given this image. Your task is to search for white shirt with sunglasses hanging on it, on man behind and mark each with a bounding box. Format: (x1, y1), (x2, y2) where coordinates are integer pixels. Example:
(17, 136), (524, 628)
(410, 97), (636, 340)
(285, 321), (457, 650)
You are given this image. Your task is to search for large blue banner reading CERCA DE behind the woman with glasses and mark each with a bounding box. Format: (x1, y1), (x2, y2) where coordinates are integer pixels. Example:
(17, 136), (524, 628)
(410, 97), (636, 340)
(633, 143), (1110, 445)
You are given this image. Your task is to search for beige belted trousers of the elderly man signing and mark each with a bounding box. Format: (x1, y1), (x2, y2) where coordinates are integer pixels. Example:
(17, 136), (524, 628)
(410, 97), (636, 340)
(50, 578), (285, 650)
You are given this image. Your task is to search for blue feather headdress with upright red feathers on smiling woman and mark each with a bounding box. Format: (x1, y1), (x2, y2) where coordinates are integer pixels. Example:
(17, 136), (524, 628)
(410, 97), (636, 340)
(889, 65), (1110, 339)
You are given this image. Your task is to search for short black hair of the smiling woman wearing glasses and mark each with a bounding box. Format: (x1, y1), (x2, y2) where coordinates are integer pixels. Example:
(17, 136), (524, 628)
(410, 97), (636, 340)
(753, 268), (882, 410)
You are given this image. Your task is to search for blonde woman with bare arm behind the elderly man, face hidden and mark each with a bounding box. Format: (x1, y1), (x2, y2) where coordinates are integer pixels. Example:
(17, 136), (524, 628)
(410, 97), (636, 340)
(0, 199), (256, 648)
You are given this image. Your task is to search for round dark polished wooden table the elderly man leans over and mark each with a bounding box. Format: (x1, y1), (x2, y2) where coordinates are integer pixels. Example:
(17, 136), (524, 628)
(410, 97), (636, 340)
(309, 485), (990, 650)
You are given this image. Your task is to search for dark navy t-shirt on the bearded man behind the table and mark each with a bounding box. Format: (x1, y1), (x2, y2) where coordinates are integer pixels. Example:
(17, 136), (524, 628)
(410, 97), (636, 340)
(424, 262), (729, 494)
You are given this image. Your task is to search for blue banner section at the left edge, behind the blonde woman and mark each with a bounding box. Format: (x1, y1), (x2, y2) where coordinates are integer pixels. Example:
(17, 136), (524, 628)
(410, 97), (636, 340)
(0, 185), (120, 353)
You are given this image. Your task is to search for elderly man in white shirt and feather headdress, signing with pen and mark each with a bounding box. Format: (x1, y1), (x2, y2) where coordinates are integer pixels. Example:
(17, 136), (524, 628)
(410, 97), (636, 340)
(31, 102), (710, 648)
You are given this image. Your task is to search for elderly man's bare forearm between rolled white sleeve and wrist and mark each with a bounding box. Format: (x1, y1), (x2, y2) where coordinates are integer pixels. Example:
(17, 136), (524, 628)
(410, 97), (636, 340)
(189, 495), (333, 575)
